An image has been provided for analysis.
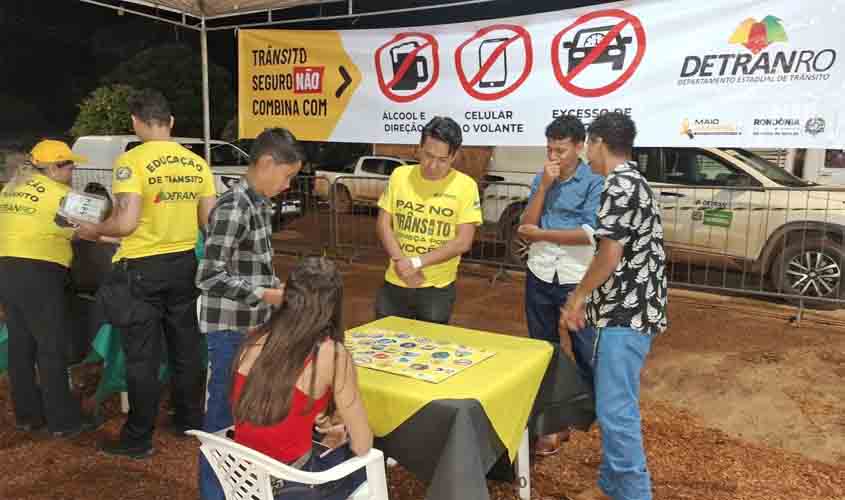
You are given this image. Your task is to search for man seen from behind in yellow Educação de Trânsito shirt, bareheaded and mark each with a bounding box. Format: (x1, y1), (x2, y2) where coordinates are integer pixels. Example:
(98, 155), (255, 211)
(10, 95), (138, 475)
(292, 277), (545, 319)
(79, 90), (216, 458)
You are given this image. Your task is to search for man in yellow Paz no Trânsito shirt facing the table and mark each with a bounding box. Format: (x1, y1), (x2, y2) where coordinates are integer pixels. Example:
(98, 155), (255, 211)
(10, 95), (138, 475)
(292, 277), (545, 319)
(376, 117), (481, 324)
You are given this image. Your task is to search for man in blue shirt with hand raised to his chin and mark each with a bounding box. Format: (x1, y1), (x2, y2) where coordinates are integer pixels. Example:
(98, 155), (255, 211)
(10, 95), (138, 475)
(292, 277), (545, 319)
(518, 116), (604, 455)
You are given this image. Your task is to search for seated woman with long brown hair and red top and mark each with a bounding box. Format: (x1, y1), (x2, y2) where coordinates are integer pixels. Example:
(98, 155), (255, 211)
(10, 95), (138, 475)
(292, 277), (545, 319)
(232, 257), (373, 500)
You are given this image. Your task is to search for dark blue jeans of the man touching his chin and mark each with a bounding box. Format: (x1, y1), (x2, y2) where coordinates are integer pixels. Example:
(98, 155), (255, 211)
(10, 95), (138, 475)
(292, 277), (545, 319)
(525, 271), (596, 387)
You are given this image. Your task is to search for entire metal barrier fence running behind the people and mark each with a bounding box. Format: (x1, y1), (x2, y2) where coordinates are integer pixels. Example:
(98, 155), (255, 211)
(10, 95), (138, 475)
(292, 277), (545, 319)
(66, 170), (845, 309)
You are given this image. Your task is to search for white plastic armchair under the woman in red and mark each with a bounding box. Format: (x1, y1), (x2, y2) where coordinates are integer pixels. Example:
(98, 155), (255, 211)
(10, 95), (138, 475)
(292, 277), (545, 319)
(186, 429), (389, 500)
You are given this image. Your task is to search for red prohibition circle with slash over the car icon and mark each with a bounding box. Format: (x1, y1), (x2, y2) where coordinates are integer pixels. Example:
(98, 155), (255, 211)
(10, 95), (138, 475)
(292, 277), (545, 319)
(552, 9), (646, 97)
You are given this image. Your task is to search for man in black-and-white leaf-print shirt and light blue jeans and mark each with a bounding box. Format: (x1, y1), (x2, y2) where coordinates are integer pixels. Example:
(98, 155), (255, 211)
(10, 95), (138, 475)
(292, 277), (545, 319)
(560, 113), (666, 500)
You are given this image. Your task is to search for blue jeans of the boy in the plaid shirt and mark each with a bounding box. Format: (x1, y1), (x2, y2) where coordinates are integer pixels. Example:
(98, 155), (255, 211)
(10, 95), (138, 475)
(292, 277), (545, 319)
(199, 330), (244, 500)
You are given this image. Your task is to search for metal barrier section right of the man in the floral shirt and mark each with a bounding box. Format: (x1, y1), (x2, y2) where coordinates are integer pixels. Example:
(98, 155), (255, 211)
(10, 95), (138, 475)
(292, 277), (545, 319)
(652, 185), (845, 309)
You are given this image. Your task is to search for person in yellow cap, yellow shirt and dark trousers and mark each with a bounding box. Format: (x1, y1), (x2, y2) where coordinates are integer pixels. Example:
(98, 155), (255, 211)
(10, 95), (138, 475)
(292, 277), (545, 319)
(0, 140), (97, 437)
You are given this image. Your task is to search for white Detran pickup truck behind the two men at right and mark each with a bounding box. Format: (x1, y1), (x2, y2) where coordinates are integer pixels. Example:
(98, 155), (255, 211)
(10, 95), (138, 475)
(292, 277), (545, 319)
(502, 148), (845, 308)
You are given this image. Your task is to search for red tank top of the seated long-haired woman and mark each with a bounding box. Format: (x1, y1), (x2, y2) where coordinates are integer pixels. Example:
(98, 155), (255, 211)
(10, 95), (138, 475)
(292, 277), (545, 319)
(232, 359), (332, 464)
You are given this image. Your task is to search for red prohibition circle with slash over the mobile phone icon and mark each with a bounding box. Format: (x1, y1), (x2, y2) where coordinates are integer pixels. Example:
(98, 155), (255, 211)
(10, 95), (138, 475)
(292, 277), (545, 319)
(455, 24), (534, 101)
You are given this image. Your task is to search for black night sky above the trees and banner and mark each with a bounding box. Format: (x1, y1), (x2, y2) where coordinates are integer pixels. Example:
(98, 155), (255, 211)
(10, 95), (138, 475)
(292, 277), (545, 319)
(0, 0), (601, 136)
